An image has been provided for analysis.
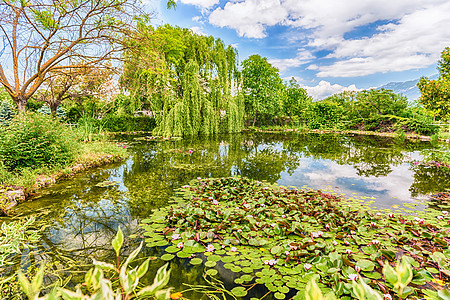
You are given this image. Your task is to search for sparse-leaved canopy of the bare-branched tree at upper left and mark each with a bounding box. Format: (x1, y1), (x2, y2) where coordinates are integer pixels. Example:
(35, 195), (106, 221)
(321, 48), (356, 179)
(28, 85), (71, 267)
(0, 0), (140, 111)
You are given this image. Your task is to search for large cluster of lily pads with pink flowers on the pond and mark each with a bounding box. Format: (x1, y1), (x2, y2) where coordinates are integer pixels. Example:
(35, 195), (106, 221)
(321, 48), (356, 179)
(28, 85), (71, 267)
(143, 177), (450, 299)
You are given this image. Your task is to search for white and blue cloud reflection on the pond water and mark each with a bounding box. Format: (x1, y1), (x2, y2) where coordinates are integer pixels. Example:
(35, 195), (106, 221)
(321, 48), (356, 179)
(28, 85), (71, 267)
(278, 158), (422, 207)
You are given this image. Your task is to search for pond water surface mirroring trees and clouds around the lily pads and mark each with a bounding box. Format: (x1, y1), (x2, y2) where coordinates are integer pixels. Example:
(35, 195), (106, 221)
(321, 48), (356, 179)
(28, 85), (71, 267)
(3, 133), (450, 299)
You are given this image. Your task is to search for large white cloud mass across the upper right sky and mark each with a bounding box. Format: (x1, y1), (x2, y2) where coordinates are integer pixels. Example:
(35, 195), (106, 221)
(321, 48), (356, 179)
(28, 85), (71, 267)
(204, 0), (450, 77)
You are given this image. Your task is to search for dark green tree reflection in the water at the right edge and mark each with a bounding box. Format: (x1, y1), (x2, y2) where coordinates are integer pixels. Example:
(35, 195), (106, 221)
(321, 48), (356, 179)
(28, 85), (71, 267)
(409, 164), (450, 197)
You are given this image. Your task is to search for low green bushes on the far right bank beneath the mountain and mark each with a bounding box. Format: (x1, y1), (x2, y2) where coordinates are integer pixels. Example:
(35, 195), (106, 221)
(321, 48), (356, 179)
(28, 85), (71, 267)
(306, 89), (438, 135)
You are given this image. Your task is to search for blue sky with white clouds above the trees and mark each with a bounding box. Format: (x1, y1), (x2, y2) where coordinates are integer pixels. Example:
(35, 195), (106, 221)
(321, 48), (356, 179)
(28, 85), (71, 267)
(145, 0), (450, 99)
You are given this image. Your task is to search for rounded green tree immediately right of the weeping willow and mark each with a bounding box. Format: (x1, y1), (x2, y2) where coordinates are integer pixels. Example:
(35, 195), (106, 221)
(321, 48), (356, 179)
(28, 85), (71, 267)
(241, 55), (284, 126)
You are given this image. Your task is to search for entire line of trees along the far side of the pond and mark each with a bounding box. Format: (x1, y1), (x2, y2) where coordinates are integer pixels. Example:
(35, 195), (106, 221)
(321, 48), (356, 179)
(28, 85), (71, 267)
(0, 0), (450, 136)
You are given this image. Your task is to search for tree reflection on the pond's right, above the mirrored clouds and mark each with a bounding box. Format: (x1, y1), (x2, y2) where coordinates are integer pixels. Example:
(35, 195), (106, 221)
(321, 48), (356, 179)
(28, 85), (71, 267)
(285, 134), (429, 177)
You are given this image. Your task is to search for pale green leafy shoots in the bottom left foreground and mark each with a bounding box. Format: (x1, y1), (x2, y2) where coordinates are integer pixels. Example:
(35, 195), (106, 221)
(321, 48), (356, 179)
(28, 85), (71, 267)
(17, 227), (171, 300)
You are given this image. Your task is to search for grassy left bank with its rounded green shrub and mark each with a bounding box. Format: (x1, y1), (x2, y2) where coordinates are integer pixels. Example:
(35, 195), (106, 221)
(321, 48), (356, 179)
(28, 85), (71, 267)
(0, 113), (127, 206)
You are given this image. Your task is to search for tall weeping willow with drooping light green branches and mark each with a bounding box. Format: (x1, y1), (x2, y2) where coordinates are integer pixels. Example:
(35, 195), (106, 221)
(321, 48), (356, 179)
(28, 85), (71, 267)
(122, 24), (244, 136)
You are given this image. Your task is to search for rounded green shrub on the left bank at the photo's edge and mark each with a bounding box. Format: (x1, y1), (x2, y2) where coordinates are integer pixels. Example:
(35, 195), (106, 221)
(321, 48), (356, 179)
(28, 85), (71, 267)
(0, 113), (79, 171)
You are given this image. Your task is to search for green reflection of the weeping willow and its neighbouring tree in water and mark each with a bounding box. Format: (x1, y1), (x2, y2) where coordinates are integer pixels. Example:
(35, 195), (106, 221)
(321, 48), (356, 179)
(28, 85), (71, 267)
(123, 134), (299, 216)
